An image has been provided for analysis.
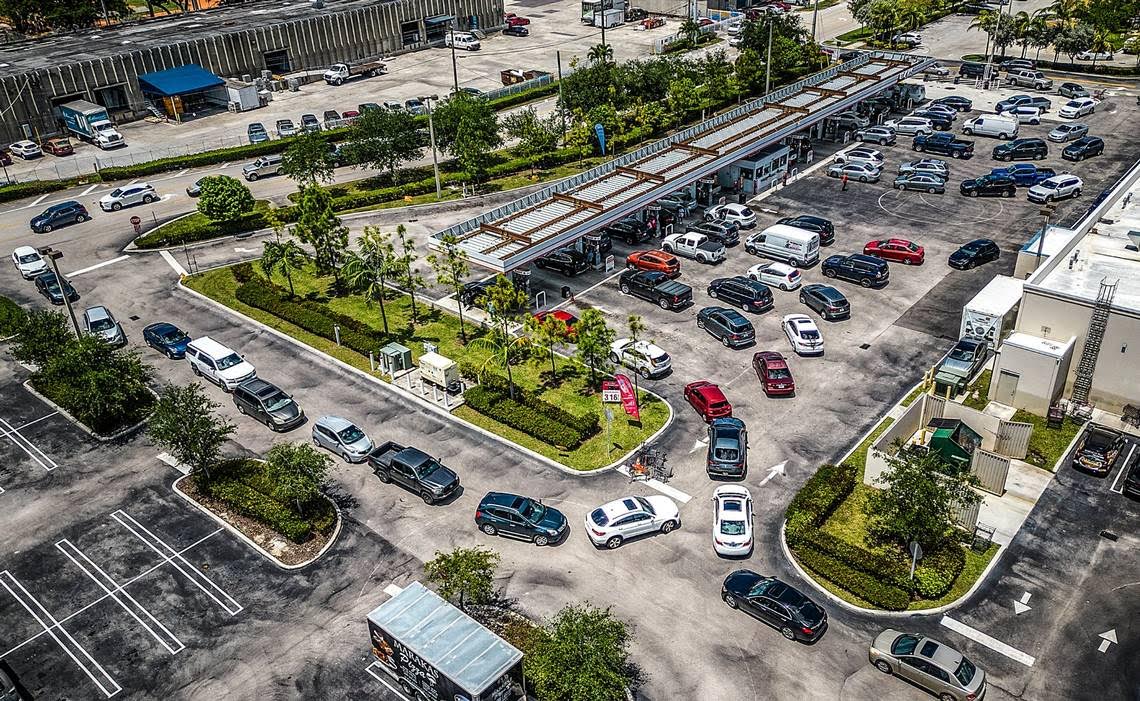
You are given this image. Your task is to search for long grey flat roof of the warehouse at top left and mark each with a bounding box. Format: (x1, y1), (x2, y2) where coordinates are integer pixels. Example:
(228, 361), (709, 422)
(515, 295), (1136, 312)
(0, 0), (399, 76)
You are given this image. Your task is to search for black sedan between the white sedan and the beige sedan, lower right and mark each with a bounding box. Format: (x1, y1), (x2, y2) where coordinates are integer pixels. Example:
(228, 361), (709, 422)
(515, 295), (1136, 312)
(720, 570), (828, 643)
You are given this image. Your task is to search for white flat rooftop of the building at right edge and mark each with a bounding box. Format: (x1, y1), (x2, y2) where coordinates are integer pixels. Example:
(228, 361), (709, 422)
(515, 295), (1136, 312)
(1034, 169), (1140, 312)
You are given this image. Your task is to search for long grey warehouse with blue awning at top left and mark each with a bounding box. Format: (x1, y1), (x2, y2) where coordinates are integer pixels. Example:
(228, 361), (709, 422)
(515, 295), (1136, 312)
(0, 0), (503, 142)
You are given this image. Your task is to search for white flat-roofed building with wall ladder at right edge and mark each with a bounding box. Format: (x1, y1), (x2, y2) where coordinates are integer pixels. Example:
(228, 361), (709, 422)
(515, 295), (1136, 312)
(990, 163), (1140, 416)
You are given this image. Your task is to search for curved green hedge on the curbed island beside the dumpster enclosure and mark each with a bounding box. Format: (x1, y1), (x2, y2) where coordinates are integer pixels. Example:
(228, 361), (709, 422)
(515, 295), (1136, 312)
(784, 464), (966, 610)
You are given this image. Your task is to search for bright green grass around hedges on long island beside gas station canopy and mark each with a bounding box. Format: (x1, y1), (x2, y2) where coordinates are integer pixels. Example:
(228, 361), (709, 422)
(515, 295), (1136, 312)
(186, 268), (669, 470)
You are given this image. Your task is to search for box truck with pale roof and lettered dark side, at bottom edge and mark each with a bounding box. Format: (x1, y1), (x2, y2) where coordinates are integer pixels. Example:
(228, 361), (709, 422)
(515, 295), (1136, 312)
(368, 581), (523, 701)
